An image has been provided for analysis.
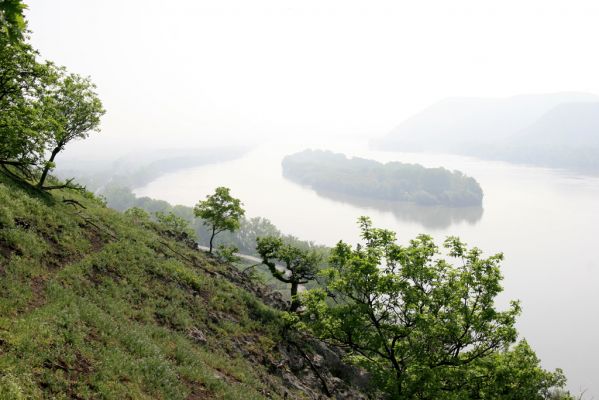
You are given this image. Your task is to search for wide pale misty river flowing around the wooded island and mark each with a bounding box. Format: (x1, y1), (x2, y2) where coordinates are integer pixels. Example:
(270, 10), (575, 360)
(135, 138), (599, 399)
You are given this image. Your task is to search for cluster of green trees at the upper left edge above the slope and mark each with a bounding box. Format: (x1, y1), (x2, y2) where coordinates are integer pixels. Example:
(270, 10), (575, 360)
(0, 0), (104, 189)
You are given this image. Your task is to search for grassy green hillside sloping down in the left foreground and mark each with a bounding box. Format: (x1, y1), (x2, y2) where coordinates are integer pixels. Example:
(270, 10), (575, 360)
(0, 177), (328, 399)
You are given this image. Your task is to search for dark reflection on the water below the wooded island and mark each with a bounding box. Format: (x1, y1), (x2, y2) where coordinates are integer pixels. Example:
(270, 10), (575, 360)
(300, 185), (483, 230)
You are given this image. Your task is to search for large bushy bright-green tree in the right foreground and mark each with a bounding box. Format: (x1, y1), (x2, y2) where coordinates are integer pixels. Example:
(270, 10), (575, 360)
(303, 217), (563, 399)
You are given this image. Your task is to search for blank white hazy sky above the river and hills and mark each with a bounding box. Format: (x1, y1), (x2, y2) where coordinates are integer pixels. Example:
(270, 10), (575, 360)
(27, 0), (599, 155)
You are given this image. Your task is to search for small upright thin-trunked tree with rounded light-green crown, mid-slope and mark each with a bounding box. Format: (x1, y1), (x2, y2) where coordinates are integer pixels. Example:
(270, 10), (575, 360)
(194, 186), (245, 254)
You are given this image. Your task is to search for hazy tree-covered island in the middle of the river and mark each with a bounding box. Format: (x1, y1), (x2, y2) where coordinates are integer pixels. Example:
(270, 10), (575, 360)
(283, 150), (483, 207)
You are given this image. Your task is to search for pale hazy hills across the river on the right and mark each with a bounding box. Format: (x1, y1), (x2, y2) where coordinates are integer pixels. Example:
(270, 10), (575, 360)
(372, 93), (599, 172)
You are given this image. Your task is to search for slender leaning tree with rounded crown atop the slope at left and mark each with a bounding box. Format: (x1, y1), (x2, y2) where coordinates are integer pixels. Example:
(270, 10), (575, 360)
(37, 68), (105, 188)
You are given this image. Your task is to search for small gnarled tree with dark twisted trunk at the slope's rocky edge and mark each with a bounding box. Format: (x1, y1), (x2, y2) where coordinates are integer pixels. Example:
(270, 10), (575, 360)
(256, 236), (322, 312)
